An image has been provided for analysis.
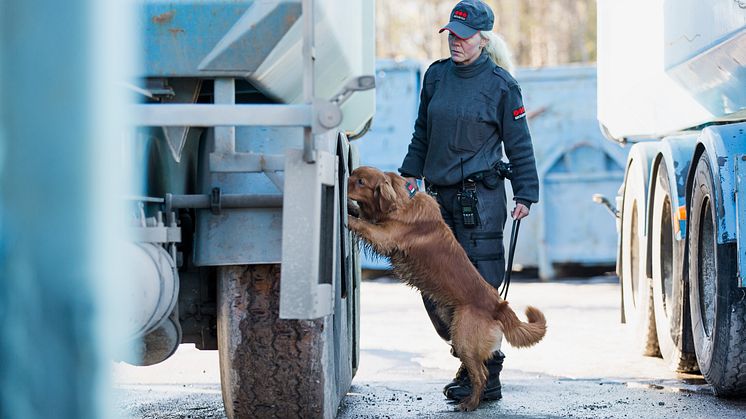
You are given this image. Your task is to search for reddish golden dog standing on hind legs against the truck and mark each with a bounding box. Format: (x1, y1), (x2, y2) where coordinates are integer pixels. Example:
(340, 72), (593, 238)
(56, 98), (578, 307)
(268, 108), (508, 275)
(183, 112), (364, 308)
(347, 167), (546, 411)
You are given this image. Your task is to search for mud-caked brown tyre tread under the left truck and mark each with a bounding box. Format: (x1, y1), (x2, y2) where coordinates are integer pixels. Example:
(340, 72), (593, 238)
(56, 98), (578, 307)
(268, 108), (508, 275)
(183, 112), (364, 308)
(217, 265), (324, 419)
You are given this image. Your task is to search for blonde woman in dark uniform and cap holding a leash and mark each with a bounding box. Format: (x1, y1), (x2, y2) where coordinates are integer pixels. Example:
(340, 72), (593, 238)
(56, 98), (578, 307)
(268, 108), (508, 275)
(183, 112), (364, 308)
(399, 0), (539, 401)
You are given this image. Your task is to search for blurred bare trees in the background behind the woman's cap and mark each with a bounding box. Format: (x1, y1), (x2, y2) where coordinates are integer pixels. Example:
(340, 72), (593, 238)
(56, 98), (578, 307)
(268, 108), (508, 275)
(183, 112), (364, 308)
(376, 0), (596, 67)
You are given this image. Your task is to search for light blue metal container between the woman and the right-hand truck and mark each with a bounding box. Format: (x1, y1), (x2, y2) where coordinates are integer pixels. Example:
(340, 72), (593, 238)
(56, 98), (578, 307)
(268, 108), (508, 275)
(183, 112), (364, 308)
(505, 66), (627, 278)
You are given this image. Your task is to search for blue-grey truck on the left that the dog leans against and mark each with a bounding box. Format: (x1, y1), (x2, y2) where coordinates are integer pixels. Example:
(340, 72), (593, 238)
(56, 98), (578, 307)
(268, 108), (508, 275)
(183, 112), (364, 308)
(122, 0), (375, 419)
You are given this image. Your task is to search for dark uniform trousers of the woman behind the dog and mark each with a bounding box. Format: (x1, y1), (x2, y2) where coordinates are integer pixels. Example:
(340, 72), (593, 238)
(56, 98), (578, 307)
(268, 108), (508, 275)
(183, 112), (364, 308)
(422, 181), (508, 341)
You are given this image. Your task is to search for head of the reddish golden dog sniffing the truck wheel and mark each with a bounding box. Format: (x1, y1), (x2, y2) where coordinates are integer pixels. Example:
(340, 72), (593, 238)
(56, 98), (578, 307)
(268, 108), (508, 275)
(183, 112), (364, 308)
(347, 166), (406, 219)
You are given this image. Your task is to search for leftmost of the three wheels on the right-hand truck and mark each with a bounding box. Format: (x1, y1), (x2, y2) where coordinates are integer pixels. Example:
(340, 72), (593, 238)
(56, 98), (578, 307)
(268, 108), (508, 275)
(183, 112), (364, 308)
(621, 154), (660, 356)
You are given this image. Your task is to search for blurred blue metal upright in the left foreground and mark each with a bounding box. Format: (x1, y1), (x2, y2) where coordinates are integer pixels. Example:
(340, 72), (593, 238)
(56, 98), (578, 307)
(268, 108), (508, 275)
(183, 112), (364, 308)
(0, 0), (135, 419)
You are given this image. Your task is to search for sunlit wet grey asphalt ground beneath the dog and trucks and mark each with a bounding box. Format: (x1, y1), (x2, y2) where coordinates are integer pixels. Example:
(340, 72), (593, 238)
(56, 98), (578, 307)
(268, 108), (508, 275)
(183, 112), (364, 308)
(113, 276), (746, 419)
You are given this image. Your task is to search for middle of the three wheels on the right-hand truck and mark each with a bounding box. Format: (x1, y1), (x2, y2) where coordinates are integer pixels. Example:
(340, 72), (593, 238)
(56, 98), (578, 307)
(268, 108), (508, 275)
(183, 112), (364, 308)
(651, 159), (697, 372)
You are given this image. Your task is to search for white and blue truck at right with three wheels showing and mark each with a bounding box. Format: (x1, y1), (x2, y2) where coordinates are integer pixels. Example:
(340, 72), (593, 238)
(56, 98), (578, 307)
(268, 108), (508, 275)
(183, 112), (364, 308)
(598, 0), (746, 397)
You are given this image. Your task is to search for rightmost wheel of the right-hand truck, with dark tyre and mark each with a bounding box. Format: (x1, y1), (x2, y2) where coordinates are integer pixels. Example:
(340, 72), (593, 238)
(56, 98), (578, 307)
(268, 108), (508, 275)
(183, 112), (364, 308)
(689, 152), (746, 397)
